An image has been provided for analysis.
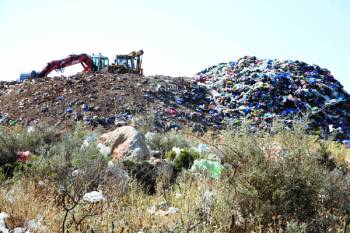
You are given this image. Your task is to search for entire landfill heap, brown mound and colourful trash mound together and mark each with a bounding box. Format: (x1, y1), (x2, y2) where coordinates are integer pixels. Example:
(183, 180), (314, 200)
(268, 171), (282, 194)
(0, 56), (350, 145)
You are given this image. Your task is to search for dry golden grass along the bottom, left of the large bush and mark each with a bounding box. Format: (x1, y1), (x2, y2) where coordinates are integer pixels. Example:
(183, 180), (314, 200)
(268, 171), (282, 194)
(0, 174), (227, 232)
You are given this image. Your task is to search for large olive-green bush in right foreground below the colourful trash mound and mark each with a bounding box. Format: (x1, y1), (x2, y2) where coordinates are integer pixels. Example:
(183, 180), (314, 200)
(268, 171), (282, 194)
(222, 121), (350, 232)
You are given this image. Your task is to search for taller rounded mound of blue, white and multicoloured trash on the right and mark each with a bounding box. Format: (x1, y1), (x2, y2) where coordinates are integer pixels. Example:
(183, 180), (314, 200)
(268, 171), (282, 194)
(197, 56), (350, 143)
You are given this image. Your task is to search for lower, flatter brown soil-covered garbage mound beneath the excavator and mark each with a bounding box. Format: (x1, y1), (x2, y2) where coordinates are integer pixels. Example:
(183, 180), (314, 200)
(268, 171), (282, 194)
(0, 73), (205, 131)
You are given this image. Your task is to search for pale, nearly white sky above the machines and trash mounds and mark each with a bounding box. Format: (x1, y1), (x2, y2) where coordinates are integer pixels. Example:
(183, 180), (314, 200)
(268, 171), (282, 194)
(0, 0), (350, 91)
